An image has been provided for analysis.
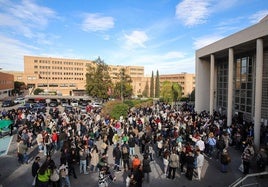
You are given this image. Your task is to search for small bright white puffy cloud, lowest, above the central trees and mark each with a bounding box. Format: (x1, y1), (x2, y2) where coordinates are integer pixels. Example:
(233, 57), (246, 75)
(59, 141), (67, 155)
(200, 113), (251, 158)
(124, 30), (149, 49)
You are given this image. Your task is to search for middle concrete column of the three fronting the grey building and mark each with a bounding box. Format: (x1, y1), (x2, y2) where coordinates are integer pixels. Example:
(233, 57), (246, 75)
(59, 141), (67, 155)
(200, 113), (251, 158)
(227, 48), (234, 126)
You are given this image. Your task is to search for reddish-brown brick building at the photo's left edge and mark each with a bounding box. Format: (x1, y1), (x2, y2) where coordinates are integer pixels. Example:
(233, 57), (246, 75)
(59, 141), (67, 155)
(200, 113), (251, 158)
(0, 72), (14, 100)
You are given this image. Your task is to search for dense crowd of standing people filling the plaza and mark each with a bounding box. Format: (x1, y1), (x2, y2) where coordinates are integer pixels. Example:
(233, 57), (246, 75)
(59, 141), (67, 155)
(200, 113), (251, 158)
(2, 102), (268, 187)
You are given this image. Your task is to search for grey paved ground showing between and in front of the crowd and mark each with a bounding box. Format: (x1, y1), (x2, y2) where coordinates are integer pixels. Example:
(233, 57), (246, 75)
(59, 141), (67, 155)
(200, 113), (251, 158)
(0, 136), (268, 187)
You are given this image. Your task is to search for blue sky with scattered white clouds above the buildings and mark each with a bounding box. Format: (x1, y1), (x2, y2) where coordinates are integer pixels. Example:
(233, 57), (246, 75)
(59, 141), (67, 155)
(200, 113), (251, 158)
(0, 0), (268, 76)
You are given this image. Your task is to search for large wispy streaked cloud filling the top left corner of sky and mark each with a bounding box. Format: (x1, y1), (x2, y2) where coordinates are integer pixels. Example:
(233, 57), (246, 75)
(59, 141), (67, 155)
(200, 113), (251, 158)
(0, 0), (57, 44)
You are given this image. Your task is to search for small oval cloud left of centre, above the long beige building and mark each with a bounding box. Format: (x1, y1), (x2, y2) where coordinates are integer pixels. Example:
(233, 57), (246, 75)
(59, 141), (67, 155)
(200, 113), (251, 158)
(82, 14), (114, 32)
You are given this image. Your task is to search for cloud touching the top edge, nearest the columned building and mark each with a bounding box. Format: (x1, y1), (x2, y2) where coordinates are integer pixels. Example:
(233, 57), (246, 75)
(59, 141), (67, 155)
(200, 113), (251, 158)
(176, 0), (211, 26)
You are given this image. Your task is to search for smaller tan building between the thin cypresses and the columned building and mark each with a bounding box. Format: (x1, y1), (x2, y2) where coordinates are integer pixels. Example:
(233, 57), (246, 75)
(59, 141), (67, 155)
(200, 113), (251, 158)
(159, 73), (195, 97)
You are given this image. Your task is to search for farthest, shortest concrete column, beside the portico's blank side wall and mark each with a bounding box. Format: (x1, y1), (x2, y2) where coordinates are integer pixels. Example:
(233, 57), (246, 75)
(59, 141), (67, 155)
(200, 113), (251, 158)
(209, 54), (215, 115)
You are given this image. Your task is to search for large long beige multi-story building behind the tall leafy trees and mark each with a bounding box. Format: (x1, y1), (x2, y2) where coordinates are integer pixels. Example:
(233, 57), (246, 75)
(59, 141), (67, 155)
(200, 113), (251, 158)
(21, 56), (144, 95)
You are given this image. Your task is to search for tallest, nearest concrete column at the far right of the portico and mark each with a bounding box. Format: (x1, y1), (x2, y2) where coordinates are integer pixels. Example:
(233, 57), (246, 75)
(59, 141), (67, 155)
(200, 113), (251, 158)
(254, 39), (263, 150)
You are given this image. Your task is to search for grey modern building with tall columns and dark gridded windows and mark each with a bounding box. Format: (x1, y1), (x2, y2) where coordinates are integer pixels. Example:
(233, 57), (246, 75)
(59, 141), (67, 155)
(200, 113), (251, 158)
(195, 16), (268, 148)
